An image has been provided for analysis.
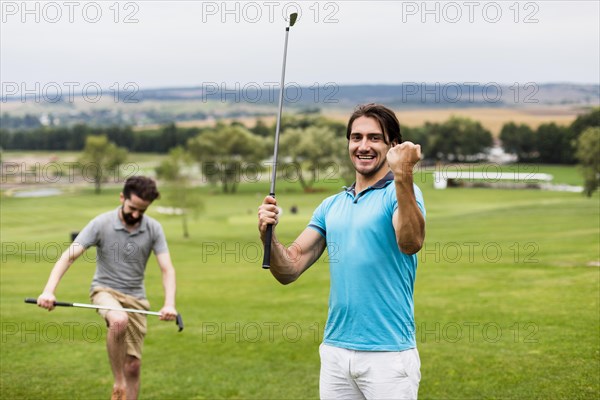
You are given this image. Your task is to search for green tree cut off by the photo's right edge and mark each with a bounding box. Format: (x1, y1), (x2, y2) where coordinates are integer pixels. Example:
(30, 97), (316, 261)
(576, 127), (600, 197)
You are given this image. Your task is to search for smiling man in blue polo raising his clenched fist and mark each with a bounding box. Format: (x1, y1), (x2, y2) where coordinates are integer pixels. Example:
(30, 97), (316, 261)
(258, 104), (425, 399)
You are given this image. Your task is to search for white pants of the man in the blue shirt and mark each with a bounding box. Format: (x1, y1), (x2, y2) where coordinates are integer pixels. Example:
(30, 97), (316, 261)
(319, 344), (421, 400)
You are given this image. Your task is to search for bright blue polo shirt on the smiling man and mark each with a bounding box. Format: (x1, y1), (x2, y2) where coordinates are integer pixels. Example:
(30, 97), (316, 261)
(308, 172), (425, 351)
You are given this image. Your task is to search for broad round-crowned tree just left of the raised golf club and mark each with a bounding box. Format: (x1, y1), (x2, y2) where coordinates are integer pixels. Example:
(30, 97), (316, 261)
(188, 124), (268, 193)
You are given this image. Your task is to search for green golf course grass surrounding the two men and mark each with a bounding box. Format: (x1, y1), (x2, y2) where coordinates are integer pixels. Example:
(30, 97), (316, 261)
(0, 167), (600, 399)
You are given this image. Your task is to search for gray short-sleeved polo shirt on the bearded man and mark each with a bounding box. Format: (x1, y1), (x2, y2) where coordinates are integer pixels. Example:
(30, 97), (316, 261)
(74, 207), (169, 299)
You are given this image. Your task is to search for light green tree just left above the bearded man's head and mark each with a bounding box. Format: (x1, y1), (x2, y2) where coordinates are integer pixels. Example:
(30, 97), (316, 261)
(79, 135), (127, 194)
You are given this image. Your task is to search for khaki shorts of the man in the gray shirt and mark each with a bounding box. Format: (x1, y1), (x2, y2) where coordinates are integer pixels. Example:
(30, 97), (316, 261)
(90, 287), (150, 360)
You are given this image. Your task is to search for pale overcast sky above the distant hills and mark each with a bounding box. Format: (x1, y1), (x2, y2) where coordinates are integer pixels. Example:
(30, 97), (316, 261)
(0, 0), (600, 88)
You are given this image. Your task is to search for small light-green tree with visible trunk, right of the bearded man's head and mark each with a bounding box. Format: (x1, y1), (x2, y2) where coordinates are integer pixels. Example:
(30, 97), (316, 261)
(156, 146), (204, 238)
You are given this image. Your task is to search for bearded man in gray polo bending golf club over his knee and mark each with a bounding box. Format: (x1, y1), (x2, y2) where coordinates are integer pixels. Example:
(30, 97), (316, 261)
(38, 176), (177, 400)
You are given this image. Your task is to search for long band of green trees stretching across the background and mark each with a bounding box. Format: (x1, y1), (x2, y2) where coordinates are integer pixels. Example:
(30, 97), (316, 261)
(0, 108), (600, 197)
